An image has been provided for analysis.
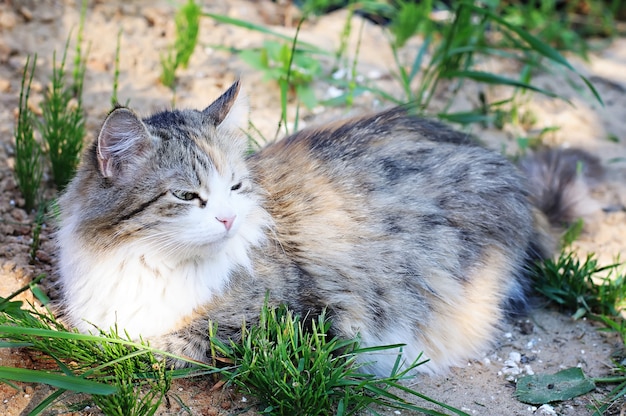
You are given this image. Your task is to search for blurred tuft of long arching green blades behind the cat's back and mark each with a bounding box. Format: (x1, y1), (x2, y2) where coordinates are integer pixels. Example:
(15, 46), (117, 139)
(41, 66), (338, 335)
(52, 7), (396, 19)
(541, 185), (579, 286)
(398, 2), (601, 122)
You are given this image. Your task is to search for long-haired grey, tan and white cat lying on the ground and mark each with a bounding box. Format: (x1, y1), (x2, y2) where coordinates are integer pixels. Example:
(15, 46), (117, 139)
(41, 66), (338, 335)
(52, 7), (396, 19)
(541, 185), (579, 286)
(57, 81), (595, 375)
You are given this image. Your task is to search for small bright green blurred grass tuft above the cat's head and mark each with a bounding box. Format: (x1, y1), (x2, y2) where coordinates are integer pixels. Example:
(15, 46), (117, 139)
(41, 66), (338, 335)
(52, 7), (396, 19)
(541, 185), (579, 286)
(161, 0), (202, 88)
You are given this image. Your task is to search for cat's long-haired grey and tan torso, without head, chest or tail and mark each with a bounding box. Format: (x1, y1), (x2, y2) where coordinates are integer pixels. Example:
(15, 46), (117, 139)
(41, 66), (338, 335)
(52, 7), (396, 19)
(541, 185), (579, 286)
(244, 109), (545, 373)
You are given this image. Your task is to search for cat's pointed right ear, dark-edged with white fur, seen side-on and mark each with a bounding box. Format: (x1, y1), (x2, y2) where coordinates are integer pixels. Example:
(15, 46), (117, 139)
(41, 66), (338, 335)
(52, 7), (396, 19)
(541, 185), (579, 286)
(202, 80), (249, 130)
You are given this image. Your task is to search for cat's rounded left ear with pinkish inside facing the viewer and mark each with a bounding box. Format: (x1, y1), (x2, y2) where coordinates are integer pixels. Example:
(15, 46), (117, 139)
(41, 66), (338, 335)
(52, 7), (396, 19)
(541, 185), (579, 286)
(97, 107), (150, 178)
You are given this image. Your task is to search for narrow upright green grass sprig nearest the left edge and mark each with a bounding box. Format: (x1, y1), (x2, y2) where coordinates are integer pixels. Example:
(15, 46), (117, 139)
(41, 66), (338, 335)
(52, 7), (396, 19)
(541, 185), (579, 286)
(14, 55), (43, 211)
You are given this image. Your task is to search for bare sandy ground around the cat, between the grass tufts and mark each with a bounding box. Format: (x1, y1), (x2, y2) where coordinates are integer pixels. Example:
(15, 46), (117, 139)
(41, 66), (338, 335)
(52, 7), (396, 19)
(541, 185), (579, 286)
(0, 0), (626, 415)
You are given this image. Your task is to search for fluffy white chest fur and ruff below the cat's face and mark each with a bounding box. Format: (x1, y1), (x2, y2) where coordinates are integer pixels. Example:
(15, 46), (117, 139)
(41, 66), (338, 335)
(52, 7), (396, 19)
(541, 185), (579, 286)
(57, 201), (268, 338)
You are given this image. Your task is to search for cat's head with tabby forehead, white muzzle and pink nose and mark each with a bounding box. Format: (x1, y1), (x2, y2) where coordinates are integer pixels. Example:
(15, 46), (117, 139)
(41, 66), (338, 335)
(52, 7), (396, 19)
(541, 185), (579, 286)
(61, 82), (268, 257)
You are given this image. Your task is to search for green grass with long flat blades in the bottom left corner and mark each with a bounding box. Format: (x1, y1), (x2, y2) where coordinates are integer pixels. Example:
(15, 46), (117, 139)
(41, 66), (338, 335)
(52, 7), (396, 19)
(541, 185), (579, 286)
(0, 282), (215, 416)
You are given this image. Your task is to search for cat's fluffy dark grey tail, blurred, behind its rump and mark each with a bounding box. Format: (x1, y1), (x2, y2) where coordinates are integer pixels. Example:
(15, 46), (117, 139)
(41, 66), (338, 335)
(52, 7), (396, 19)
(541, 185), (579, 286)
(519, 149), (604, 225)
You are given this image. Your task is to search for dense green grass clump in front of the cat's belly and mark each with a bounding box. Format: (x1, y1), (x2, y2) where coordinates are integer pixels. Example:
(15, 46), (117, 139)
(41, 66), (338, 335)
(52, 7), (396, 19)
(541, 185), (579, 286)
(213, 304), (464, 416)
